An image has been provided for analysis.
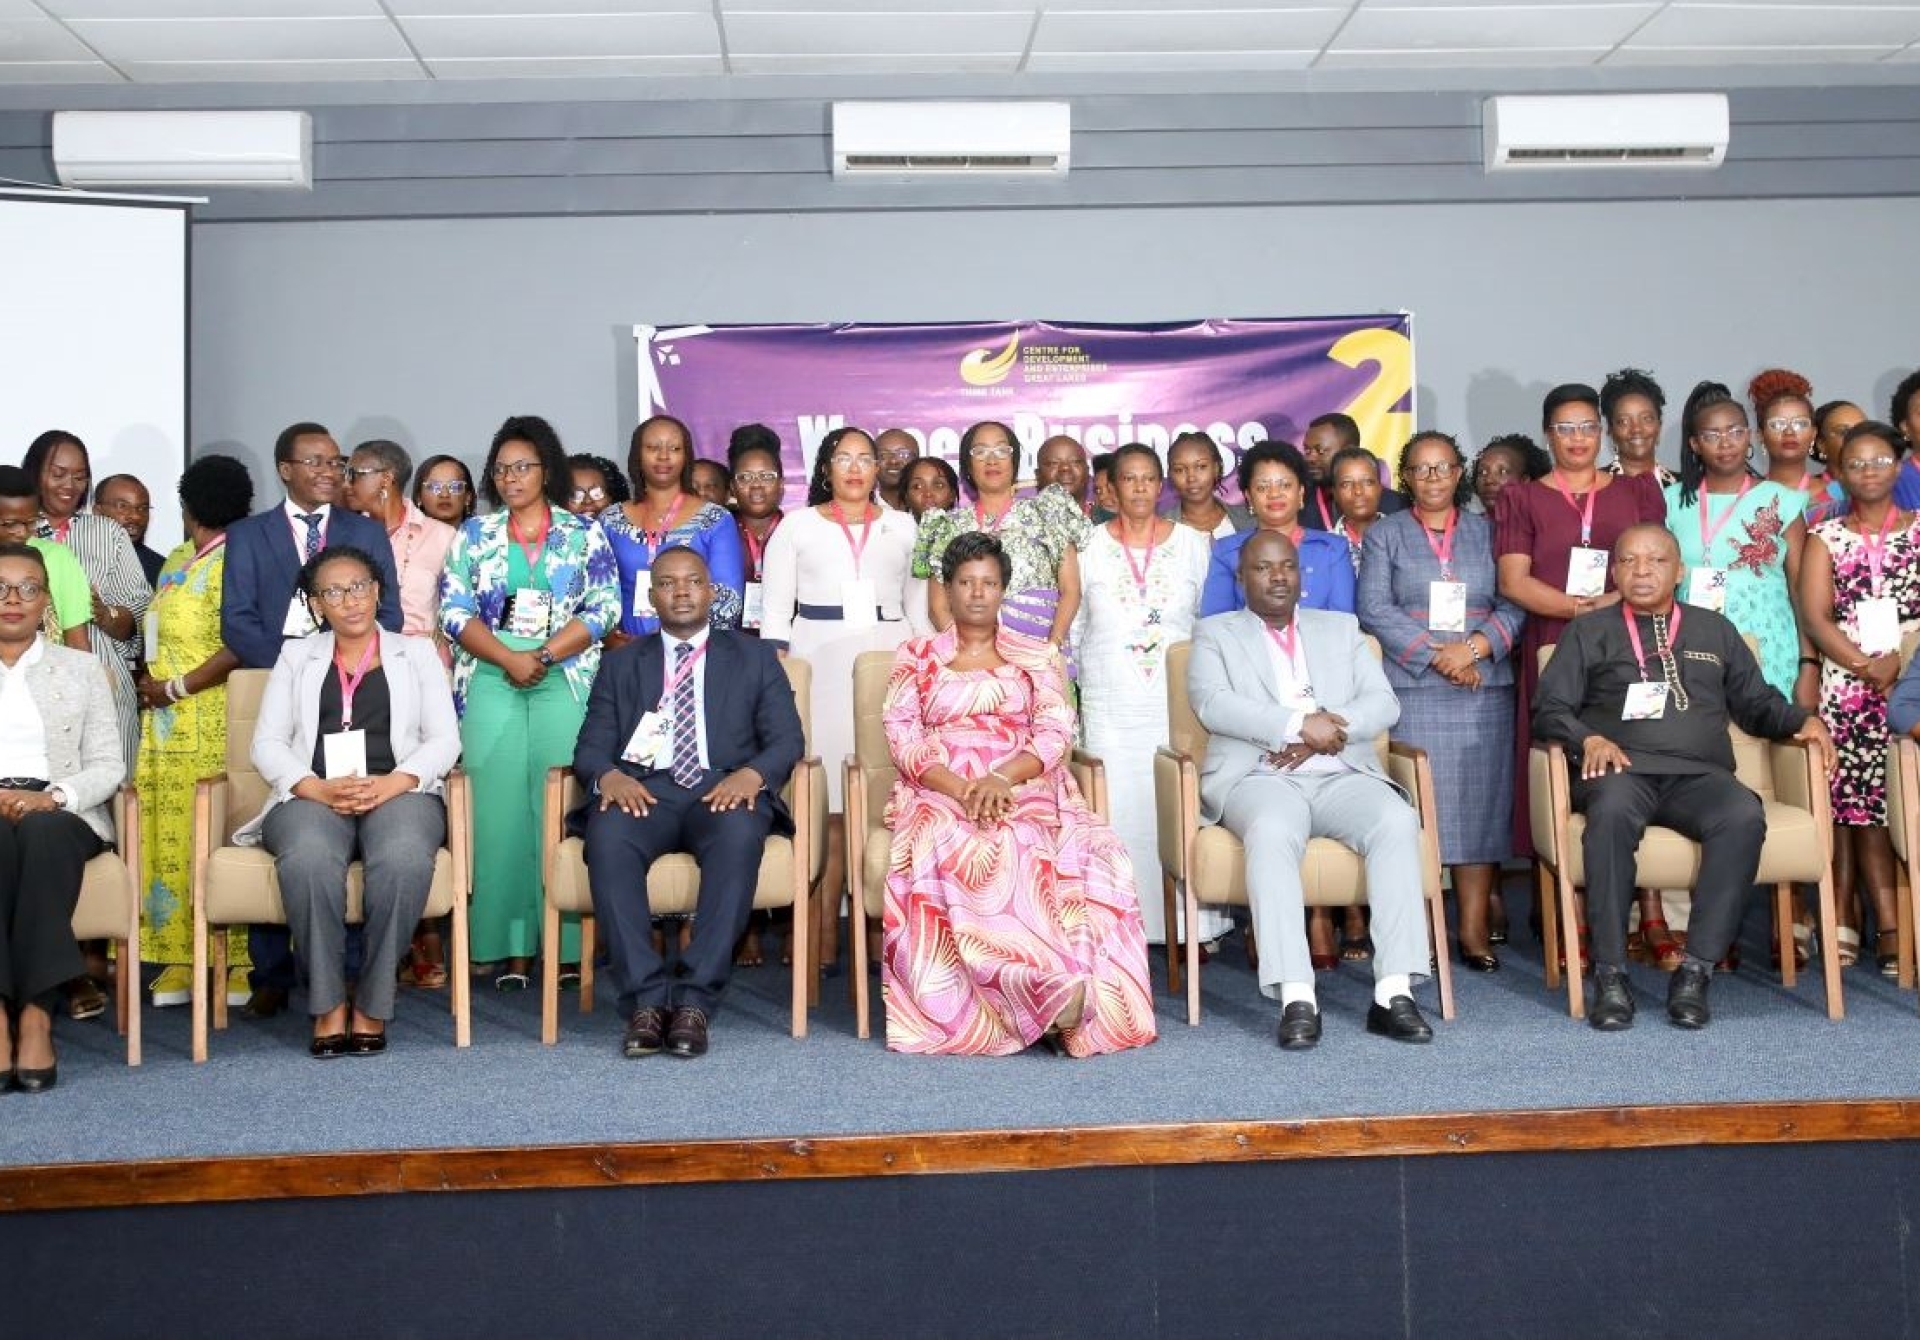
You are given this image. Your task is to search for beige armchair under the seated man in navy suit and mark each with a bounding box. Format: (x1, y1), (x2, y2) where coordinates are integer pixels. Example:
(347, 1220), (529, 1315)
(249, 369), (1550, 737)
(540, 657), (828, 1046)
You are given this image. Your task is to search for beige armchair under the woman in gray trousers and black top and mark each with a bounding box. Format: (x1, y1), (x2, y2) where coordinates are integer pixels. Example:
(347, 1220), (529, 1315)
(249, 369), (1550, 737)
(194, 670), (472, 1062)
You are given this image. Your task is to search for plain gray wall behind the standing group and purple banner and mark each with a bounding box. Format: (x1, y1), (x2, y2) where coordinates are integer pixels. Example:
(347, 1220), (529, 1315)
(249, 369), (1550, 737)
(192, 198), (1920, 481)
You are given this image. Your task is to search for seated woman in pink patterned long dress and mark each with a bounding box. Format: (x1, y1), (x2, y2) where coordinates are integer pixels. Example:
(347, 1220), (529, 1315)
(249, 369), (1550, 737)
(881, 532), (1156, 1056)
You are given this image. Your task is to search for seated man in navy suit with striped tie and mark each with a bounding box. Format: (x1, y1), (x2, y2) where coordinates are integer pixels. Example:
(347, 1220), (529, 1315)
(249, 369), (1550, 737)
(574, 547), (806, 1056)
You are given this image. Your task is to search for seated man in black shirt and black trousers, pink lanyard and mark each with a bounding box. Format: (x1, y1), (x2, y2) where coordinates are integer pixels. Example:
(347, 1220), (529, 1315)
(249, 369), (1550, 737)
(1534, 524), (1834, 1031)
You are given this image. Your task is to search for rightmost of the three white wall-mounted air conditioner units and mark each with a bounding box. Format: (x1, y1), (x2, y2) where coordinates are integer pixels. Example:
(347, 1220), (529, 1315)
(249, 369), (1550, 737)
(1482, 92), (1730, 173)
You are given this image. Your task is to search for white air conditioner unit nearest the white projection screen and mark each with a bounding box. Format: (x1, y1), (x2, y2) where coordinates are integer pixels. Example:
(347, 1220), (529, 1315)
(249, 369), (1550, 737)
(54, 111), (313, 190)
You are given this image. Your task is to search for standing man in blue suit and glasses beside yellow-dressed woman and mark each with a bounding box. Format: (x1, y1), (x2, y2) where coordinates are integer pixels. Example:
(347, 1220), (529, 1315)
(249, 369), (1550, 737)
(221, 422), (401, 1019)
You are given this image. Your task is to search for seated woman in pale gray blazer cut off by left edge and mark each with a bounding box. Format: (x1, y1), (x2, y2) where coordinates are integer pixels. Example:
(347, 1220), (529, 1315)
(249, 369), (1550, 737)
(0, 543), (125, 1094)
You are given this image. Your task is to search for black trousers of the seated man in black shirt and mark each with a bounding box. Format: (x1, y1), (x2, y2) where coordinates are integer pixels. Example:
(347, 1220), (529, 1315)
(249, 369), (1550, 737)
(1572, 772), (1766, 968)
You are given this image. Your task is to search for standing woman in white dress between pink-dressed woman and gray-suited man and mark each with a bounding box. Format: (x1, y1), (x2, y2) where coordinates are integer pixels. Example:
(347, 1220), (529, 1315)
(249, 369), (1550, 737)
(1073, 442), (1233, 945)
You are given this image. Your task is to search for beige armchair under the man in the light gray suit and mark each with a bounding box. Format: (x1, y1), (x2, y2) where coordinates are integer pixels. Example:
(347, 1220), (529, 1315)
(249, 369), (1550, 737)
(1154, 637), (1453, 1023)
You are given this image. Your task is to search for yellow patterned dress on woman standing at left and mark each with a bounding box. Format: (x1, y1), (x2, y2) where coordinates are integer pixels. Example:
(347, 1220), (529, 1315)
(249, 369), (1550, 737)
(134, 536), (252, 968)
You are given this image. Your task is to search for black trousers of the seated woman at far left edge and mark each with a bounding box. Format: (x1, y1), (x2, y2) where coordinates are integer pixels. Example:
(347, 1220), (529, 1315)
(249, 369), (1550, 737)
(0, 810), (104, 1010)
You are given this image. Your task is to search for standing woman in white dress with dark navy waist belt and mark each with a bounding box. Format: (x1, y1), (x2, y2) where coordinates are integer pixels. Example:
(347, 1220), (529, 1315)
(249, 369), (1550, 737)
(760, 428), (931, 966)
